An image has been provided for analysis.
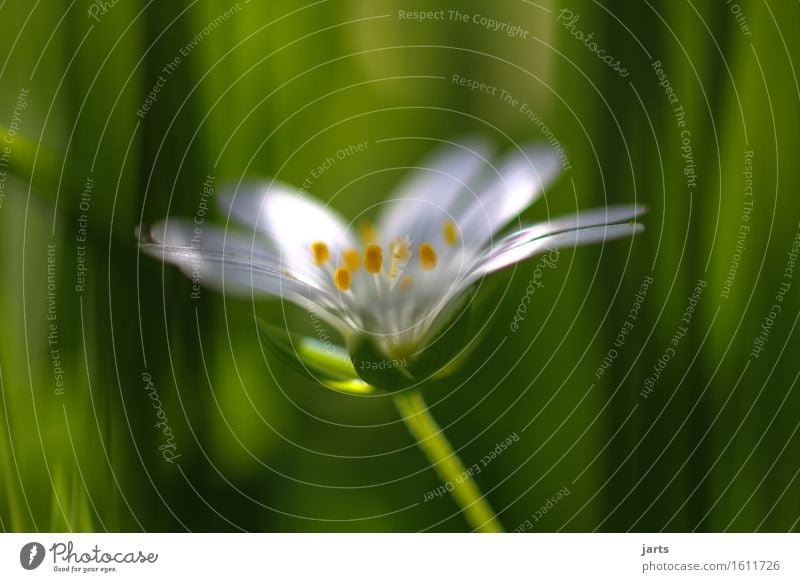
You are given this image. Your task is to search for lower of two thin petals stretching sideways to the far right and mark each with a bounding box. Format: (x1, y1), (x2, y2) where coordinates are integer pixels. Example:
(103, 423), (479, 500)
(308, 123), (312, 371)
(476, 223), (644, 276)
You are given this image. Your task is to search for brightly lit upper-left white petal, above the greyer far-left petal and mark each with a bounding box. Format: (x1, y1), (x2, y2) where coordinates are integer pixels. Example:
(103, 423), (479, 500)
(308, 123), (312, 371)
(219, 181), (354, 260)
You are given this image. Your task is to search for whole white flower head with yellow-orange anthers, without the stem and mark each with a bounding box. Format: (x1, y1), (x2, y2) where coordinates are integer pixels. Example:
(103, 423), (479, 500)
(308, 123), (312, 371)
(142, 140), (643, 386)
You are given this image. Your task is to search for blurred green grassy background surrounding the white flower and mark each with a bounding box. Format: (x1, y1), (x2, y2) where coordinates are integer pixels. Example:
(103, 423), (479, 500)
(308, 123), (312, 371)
(0, 0), (800, 531)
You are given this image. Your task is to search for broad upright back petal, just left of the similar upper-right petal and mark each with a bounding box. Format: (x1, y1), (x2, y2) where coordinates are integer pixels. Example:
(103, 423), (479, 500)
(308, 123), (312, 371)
(377, 138), (490, 244)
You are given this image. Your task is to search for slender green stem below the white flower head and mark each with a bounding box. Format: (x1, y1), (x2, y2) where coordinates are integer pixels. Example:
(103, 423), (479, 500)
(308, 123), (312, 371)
(394, 390), (503, 533)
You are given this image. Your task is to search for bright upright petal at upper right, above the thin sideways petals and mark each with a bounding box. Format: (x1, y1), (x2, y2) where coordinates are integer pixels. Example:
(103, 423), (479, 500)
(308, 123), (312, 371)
(458, 145), (561, 246)
